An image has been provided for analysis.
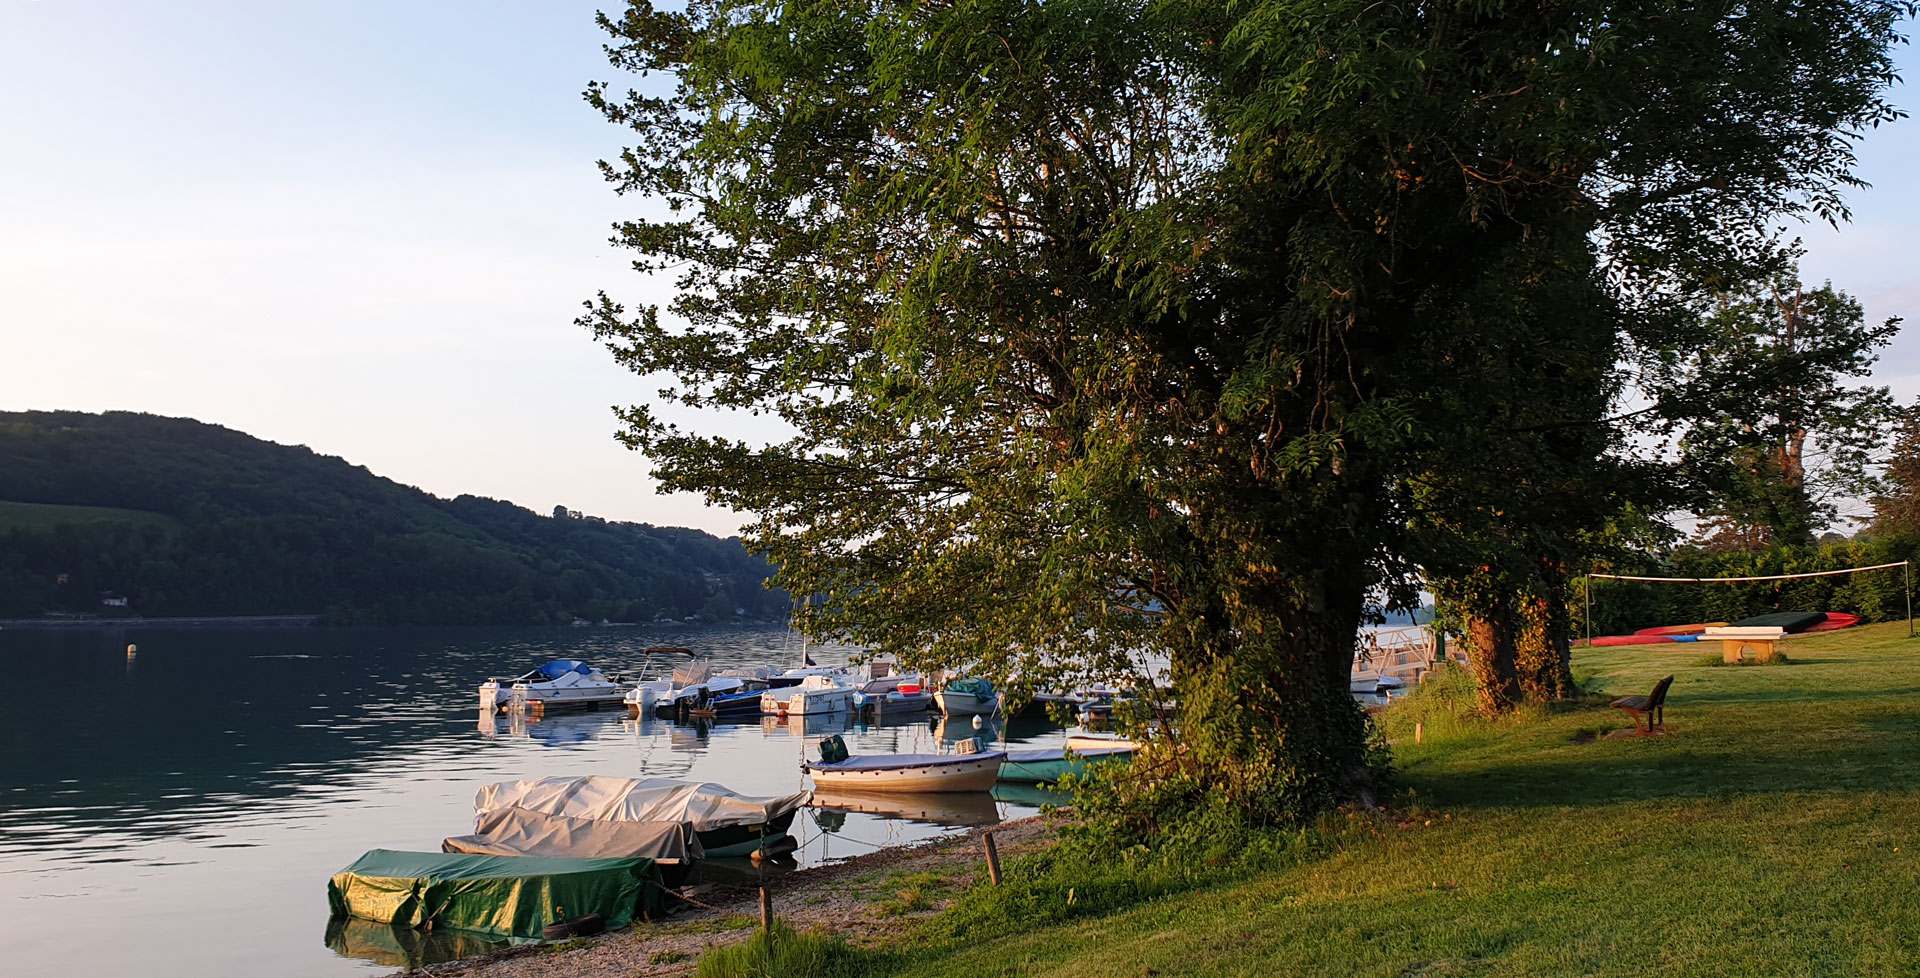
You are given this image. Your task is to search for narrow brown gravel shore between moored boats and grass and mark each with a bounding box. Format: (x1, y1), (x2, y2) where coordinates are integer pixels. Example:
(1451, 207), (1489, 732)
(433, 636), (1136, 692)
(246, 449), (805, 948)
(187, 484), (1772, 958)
(382, 815), (1050, 978)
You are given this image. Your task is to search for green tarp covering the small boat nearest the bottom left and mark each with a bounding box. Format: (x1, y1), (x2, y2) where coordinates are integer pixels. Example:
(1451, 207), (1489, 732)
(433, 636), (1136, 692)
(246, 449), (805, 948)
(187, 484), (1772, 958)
(326, 849), (662, 941)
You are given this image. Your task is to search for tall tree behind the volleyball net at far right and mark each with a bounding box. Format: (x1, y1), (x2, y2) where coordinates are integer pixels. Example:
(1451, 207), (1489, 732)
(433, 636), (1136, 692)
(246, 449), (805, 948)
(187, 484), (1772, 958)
(1668, 271), (1901, 550)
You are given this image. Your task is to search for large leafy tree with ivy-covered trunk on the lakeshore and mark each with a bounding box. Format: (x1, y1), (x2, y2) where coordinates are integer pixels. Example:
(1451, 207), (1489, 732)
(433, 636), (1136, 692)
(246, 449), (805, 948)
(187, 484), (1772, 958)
(584, 0), (1905, 820)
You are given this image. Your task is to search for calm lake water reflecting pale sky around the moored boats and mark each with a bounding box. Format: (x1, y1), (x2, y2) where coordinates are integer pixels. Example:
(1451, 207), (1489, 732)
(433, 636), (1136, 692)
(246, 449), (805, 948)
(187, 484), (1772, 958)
(0, 624), (1066, 978)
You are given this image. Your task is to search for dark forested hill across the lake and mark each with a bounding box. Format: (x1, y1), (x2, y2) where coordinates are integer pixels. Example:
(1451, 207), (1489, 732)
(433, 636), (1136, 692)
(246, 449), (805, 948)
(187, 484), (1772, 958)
(0, 411), (787, 624)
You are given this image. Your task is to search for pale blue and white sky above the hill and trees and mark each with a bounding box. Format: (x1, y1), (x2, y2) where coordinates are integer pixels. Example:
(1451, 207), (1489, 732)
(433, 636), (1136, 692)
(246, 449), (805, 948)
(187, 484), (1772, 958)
(0, 0), (1920, 536)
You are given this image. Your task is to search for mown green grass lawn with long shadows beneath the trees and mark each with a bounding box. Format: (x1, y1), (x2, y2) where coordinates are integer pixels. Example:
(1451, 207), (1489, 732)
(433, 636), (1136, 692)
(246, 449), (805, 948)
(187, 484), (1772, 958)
(871, 623), (1920, 978)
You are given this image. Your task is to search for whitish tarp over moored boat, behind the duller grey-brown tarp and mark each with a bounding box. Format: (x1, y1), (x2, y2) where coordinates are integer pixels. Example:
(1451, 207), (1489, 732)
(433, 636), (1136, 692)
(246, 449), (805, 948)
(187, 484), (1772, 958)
(474, 776), (806, 857)
